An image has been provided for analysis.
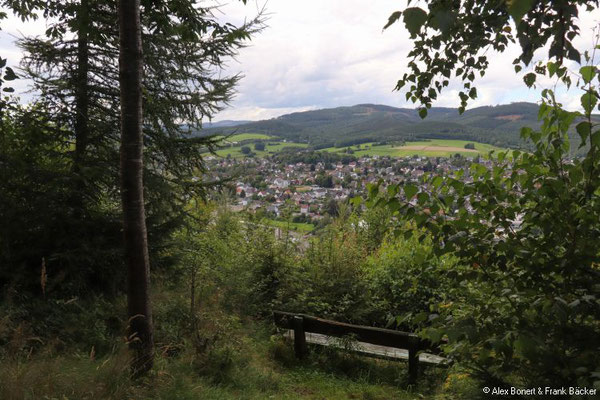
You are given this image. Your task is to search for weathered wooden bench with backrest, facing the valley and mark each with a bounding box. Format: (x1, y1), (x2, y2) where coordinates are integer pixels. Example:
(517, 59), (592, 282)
(273, 311), (447, 384)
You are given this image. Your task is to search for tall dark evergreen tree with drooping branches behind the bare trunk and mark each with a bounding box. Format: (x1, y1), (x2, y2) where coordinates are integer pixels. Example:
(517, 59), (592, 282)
(2, 0), (260, 291)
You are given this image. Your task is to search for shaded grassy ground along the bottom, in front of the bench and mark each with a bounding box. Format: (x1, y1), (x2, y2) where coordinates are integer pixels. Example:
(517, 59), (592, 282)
(0, 321), (445, 400)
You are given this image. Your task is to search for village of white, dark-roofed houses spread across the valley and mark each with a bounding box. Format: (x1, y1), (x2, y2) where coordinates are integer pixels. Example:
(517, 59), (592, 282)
(207, 154), (491, 231)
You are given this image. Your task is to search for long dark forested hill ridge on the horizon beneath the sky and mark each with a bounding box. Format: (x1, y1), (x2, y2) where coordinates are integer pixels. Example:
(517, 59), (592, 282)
(207, 102), (538, 148)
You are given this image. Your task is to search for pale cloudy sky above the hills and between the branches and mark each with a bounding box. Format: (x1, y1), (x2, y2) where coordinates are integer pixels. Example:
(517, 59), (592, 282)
(0, 0), (600, 121)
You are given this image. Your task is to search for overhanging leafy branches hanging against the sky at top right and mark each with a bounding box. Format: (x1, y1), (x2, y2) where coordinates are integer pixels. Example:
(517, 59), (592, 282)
(384, 0), (598, 111)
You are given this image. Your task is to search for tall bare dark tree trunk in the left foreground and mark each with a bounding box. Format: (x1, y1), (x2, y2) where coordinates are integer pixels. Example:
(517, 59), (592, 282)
(119, 0), (154, 375)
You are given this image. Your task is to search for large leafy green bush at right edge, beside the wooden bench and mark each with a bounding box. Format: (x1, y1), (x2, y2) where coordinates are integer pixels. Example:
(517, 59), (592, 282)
(373, 71), (600, 387)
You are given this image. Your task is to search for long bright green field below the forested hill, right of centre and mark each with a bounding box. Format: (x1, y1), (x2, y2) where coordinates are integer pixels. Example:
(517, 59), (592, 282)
(323, 139), (503, 157)
